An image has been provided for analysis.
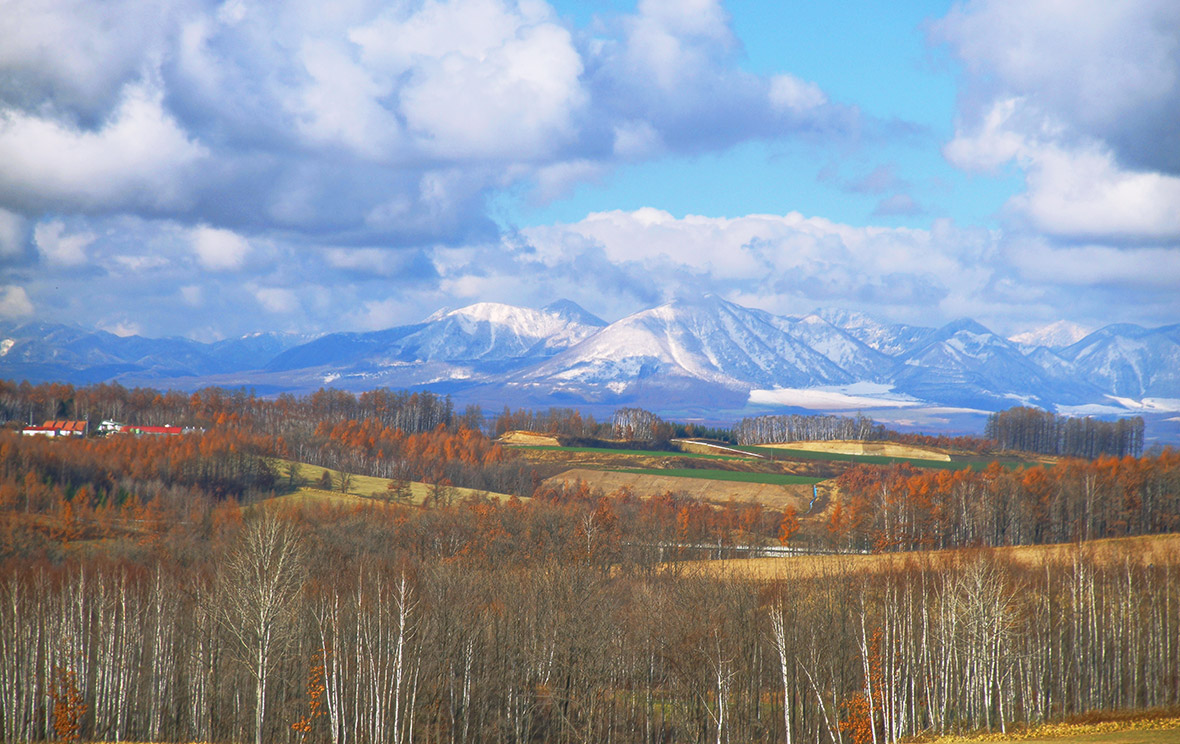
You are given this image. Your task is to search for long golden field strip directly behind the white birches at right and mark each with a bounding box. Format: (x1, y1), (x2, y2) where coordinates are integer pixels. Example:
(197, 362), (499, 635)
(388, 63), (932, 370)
(684, 534), (1180, 582)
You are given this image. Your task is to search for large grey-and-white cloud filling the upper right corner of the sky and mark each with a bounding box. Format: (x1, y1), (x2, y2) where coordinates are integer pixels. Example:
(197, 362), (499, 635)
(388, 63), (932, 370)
(932, 0), (1180, 243)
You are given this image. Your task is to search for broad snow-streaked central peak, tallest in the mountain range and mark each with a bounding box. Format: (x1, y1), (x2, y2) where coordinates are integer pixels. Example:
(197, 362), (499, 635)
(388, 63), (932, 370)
(526, 295), (852, 391)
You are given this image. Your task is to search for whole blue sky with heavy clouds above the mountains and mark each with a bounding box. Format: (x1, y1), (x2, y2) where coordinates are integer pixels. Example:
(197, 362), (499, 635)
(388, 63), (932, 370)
(0, 0), (1180, 341)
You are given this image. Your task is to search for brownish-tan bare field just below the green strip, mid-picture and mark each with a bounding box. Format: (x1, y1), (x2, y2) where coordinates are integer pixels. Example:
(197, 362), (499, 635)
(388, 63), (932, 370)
(545, 468), (824, 514)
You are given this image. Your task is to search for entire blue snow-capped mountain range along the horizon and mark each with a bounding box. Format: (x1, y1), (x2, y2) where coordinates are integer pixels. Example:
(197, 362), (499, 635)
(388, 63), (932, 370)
(0, 295), (1180, 413)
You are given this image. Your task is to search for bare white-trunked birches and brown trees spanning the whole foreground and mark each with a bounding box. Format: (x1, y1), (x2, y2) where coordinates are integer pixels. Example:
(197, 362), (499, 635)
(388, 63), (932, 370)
(0, 516), (1180, 744)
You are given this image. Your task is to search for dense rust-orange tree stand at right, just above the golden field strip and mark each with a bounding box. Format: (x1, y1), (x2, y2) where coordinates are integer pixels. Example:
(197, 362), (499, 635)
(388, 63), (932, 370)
(827, 449), (1180, 551)
